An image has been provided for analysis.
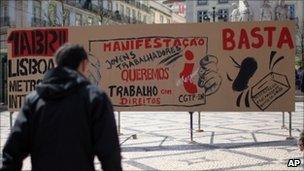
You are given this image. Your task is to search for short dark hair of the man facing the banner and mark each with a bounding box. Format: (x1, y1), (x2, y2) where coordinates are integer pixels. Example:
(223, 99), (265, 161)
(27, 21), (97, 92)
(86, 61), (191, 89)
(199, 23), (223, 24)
(55, 43), (88, 70)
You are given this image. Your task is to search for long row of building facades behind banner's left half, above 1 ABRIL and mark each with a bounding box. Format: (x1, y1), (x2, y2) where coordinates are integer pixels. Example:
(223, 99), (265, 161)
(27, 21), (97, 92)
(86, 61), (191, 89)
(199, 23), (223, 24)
(0, 0), (186, 102)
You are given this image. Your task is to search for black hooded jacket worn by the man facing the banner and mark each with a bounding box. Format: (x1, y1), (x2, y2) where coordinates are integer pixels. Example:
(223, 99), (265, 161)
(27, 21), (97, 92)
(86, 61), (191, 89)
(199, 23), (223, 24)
(0, 67), (121, 171)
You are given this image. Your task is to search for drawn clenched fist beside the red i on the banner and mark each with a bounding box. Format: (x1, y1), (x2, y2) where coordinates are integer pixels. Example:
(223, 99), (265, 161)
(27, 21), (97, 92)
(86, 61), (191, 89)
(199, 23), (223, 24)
(198, 55), (222, 96)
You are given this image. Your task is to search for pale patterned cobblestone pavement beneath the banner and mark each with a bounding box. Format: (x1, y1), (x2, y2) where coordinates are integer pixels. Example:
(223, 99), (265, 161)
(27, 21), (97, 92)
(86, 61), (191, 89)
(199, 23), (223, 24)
(0, 102), (304, 170)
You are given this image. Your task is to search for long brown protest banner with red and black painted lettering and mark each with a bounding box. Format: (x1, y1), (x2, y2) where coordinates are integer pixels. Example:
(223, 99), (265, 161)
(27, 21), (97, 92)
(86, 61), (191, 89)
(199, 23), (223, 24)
(8, 21), (295, 111)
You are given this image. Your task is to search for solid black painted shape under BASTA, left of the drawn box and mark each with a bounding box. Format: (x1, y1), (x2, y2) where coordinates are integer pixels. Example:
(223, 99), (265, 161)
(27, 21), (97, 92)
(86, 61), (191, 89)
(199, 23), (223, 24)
(227, 56), (258, 107)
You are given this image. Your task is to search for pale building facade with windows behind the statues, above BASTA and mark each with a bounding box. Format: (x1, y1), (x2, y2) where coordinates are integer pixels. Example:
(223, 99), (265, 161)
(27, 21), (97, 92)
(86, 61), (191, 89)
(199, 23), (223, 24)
(186, 0), (304, 61)
